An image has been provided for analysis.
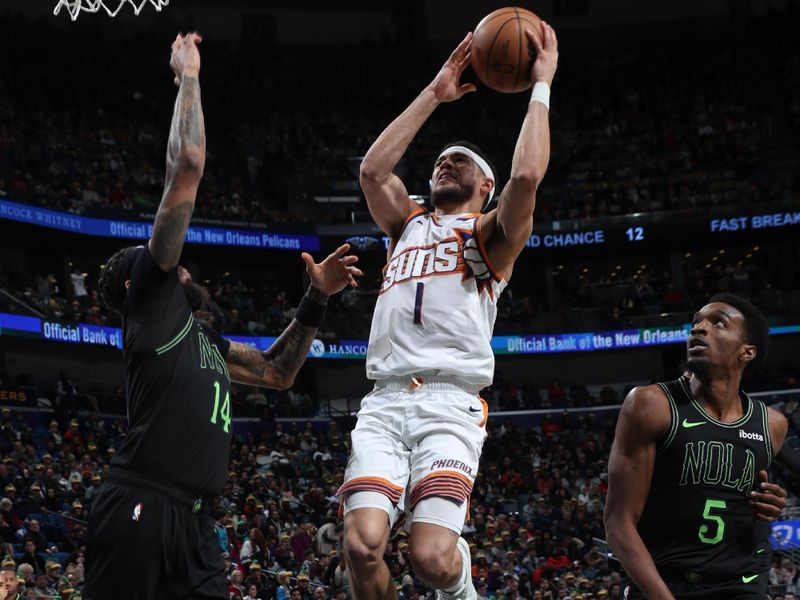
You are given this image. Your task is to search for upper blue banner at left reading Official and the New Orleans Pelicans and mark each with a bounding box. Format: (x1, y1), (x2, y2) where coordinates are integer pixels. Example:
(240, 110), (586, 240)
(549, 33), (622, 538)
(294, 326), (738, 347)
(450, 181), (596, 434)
(0, 199), (320, 252)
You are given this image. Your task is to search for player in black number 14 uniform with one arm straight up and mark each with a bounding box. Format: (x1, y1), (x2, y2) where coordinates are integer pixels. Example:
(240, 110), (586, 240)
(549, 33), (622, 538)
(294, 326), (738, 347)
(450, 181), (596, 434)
(84, 33), (360, 600)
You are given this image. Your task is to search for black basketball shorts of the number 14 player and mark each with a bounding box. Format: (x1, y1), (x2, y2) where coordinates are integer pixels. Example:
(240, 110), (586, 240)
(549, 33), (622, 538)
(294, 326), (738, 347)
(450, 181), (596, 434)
(83, 471), (228, 600)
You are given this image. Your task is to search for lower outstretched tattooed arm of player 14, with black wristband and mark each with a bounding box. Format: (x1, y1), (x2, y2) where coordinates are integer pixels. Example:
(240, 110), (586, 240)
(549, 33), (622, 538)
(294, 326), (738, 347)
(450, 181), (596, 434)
(227, 244), (362, 390)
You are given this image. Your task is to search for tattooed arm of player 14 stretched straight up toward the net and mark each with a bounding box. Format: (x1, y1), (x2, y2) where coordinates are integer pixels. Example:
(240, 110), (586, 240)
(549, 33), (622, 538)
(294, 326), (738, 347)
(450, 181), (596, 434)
(149, 33), (206, 271)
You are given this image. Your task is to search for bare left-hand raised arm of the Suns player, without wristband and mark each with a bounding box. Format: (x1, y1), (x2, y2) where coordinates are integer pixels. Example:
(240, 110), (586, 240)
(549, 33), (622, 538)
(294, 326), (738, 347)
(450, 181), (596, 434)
(359, 33), (475, 239)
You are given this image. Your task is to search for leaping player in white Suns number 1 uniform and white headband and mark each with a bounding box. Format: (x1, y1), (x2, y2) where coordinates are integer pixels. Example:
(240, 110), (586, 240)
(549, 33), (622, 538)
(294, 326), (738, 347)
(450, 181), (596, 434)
(339, 23), (558, 600)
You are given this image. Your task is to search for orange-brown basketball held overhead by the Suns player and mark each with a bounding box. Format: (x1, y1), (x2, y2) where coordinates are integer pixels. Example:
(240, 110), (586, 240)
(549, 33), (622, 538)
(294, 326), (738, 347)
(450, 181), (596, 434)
(472, 7), (542, 94)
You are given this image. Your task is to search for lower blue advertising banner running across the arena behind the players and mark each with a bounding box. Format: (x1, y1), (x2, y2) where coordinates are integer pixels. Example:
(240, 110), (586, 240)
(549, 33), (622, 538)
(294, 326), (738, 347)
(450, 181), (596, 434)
(0, 313), (800, 359)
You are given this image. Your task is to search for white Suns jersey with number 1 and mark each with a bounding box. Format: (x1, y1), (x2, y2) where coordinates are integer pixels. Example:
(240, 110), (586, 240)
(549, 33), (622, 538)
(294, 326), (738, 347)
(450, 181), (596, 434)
(367, 209), (506, 388)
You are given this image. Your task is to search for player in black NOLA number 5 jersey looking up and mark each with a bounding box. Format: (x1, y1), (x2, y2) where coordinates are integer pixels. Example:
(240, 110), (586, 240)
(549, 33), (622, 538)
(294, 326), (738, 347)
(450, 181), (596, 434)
(605, 294), (788, 600)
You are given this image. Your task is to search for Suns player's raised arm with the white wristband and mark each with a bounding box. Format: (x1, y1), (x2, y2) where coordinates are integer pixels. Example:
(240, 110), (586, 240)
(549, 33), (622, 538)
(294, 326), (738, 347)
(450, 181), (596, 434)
(489, 21), (558, 271)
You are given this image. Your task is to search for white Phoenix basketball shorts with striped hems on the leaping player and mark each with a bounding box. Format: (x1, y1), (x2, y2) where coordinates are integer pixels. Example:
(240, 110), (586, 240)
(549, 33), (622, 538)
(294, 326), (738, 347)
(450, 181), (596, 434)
(337, 376), (488, 522)
